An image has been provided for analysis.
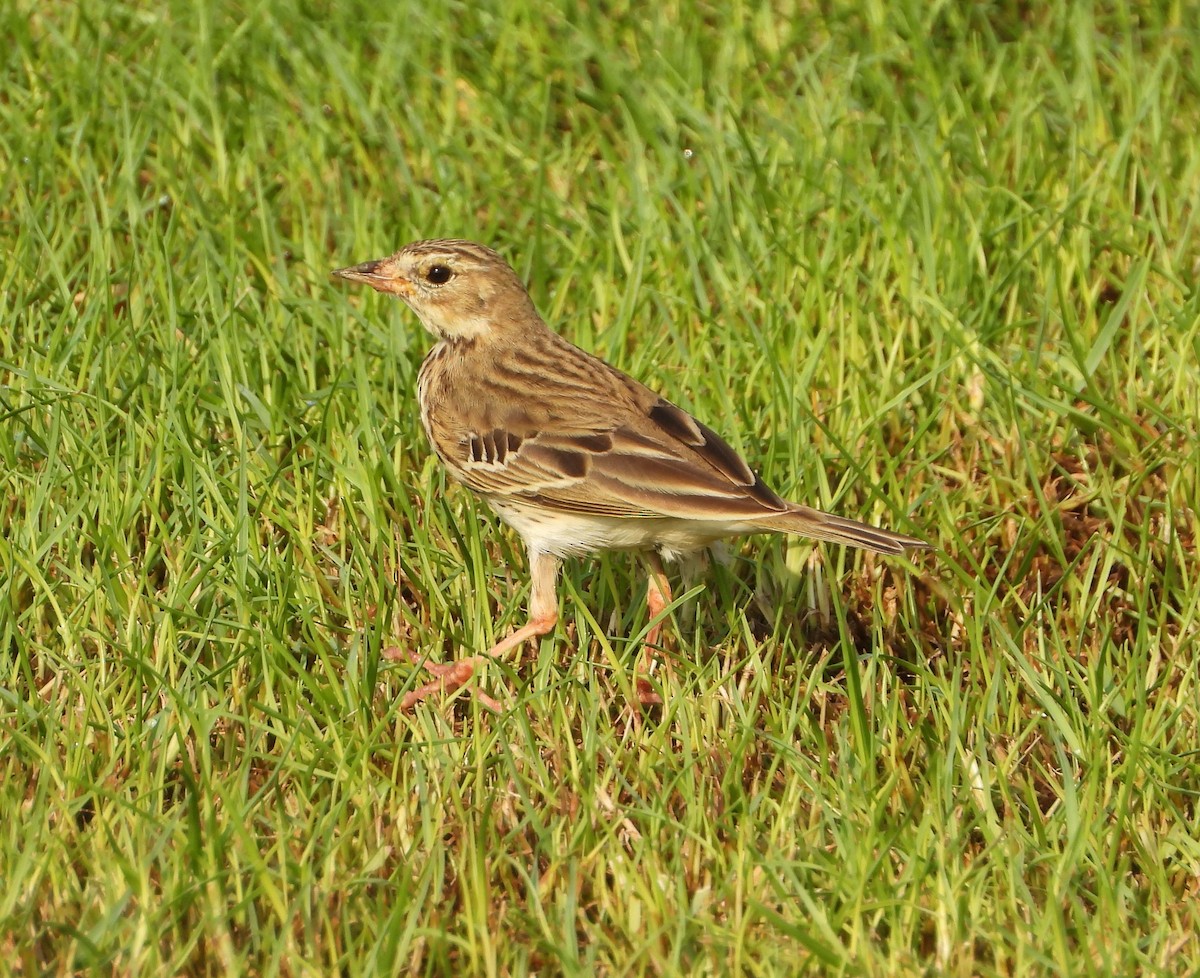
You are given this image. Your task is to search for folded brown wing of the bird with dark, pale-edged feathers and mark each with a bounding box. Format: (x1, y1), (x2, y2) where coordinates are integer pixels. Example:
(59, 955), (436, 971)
(454, 396), (788, 522)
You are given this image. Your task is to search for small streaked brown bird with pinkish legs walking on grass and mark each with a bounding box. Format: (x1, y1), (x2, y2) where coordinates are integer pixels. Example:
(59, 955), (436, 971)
(334, 240), (925, 709)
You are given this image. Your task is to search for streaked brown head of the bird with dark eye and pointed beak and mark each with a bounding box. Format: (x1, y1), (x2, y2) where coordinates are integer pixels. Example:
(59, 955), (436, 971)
(334, 239), (544, 343)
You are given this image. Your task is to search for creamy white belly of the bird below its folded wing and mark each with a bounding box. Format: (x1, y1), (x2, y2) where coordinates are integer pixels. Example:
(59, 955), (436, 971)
(487, 499), (752, 558)
